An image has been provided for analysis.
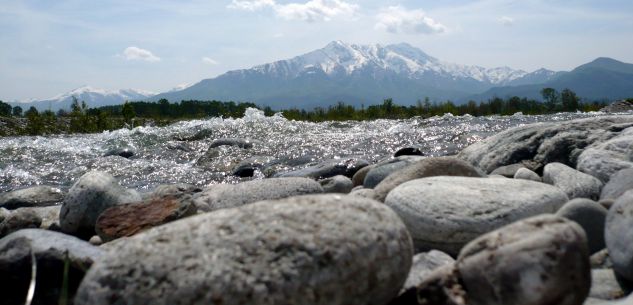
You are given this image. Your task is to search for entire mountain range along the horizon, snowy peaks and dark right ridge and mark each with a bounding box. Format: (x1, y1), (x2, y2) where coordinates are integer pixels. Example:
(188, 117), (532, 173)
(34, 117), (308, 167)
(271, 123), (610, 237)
(12, 41), (633, 109)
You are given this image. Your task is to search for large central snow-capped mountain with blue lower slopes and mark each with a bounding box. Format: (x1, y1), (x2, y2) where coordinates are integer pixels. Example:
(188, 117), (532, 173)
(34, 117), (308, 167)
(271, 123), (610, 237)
(152, 41), (556, 108)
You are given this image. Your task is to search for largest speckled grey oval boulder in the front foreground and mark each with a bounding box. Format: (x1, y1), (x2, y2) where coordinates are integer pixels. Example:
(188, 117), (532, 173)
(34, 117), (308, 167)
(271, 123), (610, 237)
(75, 195), (412, 305)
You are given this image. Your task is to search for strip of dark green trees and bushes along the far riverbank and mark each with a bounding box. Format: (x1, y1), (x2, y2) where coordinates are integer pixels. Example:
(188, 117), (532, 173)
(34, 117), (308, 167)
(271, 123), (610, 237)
(0, 88), (624, 136)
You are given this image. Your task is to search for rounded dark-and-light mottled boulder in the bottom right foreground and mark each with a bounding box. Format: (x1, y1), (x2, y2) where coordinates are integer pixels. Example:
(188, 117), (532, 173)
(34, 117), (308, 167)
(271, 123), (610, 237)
(417, 215), (591, 305)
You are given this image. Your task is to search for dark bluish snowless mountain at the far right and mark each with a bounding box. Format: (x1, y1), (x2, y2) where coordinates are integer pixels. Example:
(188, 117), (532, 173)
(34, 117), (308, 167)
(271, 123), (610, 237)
(465, 57), (633, 101)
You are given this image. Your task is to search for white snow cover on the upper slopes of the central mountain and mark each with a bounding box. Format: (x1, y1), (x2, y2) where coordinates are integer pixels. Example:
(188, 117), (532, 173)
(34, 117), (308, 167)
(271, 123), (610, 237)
(241, 41), (528, 85)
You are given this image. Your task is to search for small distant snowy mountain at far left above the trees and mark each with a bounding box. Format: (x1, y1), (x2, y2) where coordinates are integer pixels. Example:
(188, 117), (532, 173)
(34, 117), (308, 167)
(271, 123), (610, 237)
(11, 86), (155, 111)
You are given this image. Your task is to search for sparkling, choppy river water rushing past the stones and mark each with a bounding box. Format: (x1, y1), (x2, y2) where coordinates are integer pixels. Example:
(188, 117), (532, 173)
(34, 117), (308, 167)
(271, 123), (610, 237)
(0, 109), (624, 192)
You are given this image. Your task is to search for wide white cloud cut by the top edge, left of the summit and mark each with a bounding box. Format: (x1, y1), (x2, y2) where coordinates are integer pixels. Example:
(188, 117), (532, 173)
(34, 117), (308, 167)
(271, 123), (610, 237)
(227, 0), (359, 22)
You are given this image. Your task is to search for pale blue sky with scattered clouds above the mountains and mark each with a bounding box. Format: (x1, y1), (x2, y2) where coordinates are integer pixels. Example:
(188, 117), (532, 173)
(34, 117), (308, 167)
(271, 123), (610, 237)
(0, 0), (633, 101)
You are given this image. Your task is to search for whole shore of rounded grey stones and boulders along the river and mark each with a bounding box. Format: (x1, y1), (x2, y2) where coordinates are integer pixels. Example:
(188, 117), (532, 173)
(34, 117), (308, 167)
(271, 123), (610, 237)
(0, 116), (633, 305)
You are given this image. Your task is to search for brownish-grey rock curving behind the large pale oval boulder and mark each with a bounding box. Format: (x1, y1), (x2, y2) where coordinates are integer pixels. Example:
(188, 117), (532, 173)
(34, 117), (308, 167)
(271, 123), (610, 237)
(374, 157), (484, 201)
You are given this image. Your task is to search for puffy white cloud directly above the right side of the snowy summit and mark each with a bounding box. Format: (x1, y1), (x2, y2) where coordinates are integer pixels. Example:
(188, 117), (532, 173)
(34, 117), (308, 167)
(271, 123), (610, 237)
(376, 6), (447, 34)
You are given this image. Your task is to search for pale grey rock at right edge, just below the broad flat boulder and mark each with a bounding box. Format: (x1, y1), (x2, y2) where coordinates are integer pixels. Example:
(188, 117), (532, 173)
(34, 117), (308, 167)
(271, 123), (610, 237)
(576, 124), (633, 183)
